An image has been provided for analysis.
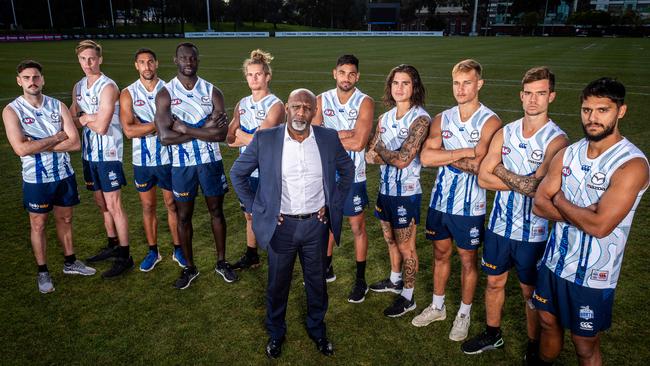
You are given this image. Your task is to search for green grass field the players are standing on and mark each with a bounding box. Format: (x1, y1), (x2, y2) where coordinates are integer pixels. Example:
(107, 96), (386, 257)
(0, 38), (650, 366)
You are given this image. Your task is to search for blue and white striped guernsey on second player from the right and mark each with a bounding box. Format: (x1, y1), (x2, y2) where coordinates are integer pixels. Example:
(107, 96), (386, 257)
(488, 119), (566, 242)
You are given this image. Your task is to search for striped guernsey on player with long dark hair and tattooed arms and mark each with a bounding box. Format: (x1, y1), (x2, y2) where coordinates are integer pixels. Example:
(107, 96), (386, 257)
(379, 106), (430, 197)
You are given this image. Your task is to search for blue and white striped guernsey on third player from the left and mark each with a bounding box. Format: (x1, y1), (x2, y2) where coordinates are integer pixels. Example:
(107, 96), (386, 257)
(127, 79), (171, 166)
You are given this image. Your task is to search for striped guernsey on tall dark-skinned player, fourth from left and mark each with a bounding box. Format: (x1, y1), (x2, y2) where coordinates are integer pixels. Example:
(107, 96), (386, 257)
(165, 78), (221, 167)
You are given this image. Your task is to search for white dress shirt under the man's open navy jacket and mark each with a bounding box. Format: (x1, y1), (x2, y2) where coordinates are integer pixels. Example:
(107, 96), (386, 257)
(280, 126), (325, 215)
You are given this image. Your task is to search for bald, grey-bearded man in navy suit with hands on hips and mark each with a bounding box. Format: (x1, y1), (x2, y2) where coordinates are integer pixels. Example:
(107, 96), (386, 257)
(230, 89), (354, 358)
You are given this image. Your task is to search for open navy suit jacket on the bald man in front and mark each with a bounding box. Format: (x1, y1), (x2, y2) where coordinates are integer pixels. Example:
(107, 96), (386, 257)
(230, 124), (354, 250)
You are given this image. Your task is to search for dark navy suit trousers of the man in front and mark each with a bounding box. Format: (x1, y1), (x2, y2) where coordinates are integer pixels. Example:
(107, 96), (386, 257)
(266, 216), (330, 339)
